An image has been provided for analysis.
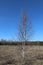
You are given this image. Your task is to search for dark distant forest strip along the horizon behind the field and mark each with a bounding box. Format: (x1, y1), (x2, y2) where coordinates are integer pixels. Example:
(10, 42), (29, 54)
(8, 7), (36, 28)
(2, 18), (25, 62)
(0, 40), (43, 45)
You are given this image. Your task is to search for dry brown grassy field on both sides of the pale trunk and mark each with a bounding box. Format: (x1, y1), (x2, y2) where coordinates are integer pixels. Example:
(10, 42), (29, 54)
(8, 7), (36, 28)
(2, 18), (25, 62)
(0, 45), (43, 65)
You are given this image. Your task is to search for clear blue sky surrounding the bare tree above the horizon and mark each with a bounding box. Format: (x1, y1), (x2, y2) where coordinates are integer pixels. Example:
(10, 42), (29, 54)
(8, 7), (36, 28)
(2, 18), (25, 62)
(0, 0), (43, 41)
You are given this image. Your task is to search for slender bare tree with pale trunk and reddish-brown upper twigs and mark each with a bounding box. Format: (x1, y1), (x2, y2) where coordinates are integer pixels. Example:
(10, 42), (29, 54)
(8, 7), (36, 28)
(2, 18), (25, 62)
(19, 12), (32, 65)
